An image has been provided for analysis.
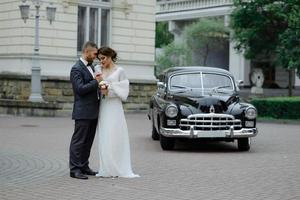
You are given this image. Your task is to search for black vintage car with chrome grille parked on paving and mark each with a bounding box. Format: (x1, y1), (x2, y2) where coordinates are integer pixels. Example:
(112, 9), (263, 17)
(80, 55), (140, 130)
(148, 67), (257, 151)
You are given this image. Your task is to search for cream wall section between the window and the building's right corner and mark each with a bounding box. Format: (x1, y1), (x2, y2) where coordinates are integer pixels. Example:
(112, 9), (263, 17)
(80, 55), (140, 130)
(111, 0), (155, 80)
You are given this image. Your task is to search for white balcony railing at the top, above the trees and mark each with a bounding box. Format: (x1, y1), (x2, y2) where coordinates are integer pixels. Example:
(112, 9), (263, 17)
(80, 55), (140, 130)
(156, 0), (232, 14)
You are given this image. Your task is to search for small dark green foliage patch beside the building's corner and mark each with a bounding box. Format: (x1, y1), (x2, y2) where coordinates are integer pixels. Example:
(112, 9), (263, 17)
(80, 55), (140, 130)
(155, 22), (174, 48)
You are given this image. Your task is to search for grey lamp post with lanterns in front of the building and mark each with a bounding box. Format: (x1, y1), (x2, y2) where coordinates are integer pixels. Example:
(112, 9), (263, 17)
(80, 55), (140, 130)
(19, 0), (56, 102)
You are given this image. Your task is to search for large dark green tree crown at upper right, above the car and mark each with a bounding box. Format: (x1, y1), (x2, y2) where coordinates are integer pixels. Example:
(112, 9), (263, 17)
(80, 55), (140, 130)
(230, 0), (287, 59)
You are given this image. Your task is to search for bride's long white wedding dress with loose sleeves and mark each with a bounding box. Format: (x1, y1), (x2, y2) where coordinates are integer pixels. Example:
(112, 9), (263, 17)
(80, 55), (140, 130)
(96, 67), (139, 178)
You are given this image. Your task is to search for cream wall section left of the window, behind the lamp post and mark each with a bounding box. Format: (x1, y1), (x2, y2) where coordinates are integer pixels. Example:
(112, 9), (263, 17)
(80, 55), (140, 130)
(0, 0), (77, 76)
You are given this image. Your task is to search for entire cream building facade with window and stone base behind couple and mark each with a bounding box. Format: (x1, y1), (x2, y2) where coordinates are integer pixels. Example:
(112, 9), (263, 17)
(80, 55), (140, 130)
(0, 0), (156, 115)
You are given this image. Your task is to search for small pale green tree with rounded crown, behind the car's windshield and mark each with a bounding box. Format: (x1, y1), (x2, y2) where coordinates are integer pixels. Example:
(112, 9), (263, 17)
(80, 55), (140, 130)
(184, 18), (229, 66)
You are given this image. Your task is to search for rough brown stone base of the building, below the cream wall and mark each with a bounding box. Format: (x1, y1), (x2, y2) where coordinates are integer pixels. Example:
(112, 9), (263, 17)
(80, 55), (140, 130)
(0, 74), (156, 117)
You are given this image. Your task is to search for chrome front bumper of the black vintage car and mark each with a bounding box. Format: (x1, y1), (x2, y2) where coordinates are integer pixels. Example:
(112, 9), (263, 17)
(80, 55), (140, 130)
(160, 127), (258, 138)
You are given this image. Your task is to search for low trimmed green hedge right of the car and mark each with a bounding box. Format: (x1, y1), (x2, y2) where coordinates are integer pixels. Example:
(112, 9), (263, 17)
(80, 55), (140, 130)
(251, 96), (300, 119)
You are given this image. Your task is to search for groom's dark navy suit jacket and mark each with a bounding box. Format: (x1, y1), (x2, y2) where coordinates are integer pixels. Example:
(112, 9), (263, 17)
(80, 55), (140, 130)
(70, 60), (100, 119)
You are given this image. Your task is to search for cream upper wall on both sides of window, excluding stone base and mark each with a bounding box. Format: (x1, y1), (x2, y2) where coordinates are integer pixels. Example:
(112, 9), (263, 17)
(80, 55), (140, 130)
(0, 0), (155, 80)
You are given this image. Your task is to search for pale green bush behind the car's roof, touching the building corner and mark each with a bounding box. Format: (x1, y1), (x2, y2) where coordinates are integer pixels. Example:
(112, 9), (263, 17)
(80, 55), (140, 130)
(156, 42), (191, 74)
